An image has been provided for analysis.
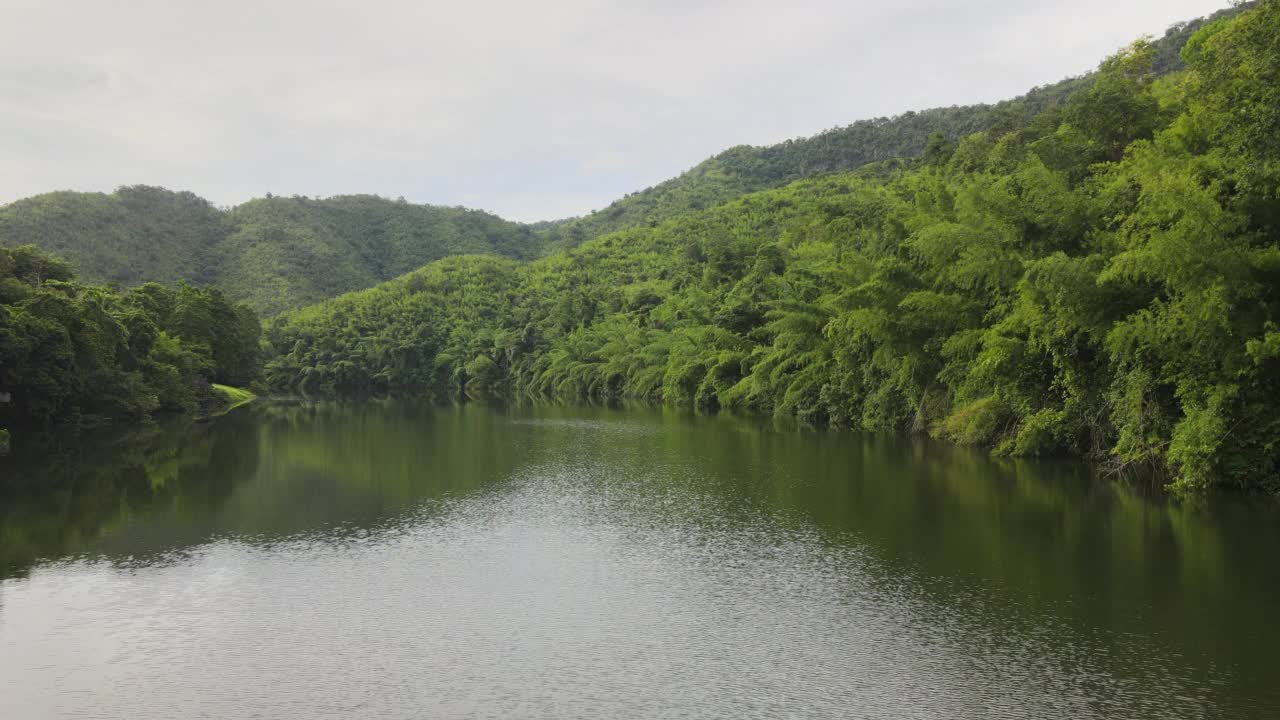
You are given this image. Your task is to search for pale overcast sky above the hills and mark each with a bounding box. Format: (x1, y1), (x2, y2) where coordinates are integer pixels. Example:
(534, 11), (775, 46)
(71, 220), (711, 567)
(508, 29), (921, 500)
(0, 0), (1228, 220)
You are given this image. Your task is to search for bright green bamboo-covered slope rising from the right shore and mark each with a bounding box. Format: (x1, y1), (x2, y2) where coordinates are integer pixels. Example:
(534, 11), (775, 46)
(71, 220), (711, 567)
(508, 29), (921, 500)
(266, 0), (1280, 491)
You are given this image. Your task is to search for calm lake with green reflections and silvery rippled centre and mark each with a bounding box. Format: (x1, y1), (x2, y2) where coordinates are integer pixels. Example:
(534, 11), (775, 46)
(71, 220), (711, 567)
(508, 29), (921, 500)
(0, 401), (1280, 720)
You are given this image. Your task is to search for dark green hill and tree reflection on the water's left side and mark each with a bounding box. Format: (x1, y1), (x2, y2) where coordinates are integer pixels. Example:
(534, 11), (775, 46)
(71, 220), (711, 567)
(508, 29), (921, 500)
(0, 401), (522, 577)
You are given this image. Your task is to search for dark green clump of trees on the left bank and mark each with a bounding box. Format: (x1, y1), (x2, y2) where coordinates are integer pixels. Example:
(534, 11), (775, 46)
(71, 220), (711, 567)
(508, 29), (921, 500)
(0, 246), (261, 428)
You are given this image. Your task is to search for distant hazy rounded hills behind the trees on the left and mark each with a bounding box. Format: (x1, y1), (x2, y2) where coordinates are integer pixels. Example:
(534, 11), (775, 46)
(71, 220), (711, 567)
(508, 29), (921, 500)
(0, 186), (540, 315)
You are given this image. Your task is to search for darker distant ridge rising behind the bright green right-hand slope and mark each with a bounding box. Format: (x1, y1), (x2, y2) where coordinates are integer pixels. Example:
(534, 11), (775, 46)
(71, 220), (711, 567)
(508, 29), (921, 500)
(544, 3), (1256, 249)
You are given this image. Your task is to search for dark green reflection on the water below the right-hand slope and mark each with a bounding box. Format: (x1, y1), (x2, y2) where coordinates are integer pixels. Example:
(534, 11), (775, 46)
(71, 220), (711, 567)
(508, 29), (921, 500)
(558, 414), (1280, 696)
